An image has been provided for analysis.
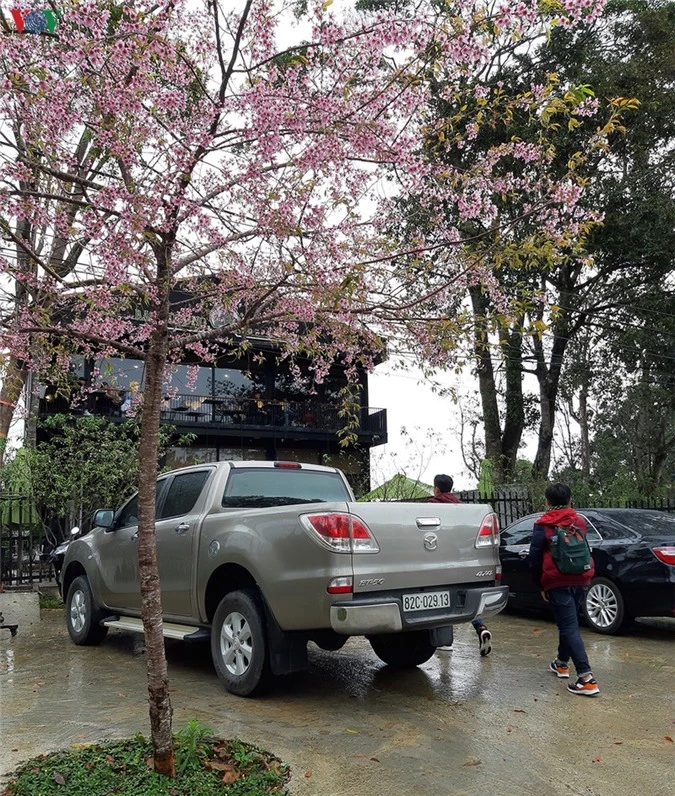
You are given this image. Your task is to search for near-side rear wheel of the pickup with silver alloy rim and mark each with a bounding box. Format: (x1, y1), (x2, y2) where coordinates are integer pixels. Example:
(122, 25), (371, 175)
(211, 589), (270, 696)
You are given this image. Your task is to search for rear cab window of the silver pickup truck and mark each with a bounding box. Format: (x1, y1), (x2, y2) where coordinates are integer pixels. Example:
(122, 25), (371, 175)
(222, 467), (351, 508)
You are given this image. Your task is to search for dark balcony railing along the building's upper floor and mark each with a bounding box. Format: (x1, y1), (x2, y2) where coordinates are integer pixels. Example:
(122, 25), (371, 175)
(40, 393), (387, 442)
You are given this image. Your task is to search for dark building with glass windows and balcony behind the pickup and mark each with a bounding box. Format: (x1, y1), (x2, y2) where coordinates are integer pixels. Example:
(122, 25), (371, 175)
(38, 341), (387, 494)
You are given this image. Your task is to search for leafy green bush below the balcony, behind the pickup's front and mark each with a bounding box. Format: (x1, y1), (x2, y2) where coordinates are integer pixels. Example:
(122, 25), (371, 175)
(3, 415), (195, 532)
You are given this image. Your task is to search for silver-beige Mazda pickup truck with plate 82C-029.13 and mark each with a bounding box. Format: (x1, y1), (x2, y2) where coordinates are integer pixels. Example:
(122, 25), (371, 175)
(62, 461), (508, 696)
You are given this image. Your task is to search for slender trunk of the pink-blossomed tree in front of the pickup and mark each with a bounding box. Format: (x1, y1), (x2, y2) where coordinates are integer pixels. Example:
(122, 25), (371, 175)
(138, 250), (176, 777)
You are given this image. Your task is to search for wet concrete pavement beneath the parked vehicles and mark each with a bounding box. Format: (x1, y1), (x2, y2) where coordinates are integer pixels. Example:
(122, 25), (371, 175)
(0, 611), (675, 796)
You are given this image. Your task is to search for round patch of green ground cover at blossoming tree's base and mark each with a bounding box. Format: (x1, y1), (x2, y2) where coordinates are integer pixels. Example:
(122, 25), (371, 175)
(0, 721), (290, 796)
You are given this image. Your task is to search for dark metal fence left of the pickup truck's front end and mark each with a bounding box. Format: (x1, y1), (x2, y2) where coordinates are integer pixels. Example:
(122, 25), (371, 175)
(0, 493), (53, 586)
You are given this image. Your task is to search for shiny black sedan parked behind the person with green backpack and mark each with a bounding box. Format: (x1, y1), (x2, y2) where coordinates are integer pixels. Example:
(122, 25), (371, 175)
(499, 509), (675, 634)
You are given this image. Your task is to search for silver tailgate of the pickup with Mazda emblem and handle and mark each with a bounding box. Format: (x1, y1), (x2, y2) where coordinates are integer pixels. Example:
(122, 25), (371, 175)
(349, 503), (498, 594)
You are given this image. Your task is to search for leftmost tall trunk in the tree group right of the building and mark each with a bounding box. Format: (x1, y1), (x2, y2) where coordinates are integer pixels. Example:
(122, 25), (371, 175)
(469, 285), (502, 482)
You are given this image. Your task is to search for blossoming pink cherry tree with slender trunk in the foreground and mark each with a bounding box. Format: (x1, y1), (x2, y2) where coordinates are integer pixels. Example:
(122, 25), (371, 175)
(0, 0), (600, 774)
